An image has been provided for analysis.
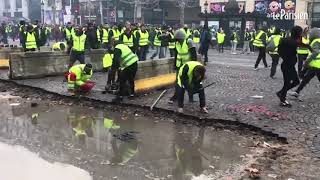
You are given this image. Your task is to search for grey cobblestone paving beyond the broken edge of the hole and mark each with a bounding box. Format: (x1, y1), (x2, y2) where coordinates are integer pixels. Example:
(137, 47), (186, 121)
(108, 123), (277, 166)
(1, 51), (320, 157)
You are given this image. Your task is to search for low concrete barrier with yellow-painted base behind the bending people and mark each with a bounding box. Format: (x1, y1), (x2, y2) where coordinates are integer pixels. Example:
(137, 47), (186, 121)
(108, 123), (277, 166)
(9, 49), (180, 92)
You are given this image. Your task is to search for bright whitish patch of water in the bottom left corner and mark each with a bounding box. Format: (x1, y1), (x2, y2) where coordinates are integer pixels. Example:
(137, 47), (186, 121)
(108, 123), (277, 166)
(0, 142), (92, 180)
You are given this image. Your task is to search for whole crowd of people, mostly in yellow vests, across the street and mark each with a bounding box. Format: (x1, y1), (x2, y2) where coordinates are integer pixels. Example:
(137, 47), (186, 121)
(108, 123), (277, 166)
(0, 21), (320, 109)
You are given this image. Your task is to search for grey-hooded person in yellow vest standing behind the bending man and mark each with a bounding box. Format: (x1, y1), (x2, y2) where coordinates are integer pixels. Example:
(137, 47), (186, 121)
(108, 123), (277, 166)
(168, 29), (197, 104)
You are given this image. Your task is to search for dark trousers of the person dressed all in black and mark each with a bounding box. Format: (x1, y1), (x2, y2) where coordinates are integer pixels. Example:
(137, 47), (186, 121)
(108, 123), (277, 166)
(279, 63), (300, 102)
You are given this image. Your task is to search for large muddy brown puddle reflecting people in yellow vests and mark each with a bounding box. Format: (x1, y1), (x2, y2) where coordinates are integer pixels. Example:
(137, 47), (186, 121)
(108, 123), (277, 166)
(0, 95), (256, 180)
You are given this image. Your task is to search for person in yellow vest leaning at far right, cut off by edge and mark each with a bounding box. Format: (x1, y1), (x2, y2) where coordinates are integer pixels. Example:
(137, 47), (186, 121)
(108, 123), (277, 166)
(289, 28), (320, 98)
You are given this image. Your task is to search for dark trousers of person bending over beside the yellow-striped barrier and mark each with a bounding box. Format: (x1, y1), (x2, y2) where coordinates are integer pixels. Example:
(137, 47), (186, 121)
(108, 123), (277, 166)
(118, 62), (138, 96)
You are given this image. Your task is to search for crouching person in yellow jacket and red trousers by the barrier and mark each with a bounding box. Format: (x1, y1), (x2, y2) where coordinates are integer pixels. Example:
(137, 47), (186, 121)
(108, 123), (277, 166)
(66, 64), (95, 95)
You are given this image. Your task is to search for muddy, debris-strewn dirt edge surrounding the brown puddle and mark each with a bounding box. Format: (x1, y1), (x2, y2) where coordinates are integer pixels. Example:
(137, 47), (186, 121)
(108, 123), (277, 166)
(0, 82), (320, 180)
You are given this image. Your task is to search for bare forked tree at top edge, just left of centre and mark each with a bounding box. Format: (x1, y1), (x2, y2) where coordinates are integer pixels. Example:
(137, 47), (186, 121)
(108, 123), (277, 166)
(120, 0), (159, 22)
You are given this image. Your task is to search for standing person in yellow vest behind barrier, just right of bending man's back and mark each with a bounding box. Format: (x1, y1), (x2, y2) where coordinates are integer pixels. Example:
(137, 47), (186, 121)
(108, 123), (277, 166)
(136, 24), (150, 61)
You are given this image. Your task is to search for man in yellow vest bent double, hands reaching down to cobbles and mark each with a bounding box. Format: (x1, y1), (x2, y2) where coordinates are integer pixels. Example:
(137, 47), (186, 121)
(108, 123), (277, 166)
(177, 61), (208, 113)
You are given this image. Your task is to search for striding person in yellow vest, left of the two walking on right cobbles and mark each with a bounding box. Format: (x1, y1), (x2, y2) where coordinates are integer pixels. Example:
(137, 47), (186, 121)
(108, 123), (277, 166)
(253, 27), (268, 70)
